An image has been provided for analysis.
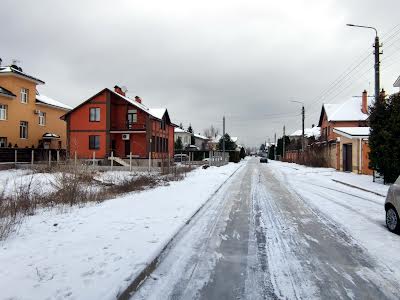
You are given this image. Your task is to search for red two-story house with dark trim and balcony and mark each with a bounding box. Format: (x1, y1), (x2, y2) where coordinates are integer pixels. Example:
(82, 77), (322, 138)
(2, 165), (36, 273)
(62, 86), (176, 159)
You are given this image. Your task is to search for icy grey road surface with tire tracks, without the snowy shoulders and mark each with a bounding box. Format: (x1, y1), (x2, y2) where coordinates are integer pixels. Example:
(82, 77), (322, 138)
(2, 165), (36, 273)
(132, 159), (400, 300)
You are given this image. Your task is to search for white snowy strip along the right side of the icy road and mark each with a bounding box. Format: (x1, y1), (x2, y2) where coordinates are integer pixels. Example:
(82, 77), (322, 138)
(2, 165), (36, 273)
(268, 161), (400, 278)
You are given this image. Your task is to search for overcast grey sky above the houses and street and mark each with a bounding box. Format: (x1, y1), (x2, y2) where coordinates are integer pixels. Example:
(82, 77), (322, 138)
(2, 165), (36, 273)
(0, 0), (400, 146)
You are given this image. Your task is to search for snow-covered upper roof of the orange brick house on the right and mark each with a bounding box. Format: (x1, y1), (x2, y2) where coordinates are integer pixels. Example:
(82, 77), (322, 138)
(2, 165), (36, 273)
(318, 97), (370, 126)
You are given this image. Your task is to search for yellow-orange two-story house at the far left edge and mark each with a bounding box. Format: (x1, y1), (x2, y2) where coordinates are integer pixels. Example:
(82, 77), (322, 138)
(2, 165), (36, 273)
(0, 65), (71, 149)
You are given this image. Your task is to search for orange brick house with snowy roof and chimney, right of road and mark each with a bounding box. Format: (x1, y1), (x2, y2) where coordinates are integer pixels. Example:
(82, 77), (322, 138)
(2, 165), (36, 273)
(318, 91), (372, 174)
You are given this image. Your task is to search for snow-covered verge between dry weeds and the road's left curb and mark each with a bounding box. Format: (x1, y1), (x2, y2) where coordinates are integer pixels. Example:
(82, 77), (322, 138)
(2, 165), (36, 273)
(0, 162), (246, 299)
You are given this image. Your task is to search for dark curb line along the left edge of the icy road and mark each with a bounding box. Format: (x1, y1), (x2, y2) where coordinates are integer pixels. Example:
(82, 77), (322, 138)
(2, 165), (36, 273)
(116, 165), (243, 300)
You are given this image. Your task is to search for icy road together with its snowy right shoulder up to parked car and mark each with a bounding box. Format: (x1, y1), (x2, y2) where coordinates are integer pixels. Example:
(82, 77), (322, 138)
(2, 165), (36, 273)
(133, 159), (400, 299)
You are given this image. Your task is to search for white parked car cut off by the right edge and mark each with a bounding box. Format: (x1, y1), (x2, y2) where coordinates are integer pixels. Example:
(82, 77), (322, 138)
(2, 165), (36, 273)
(385, 176), (400, 233)
